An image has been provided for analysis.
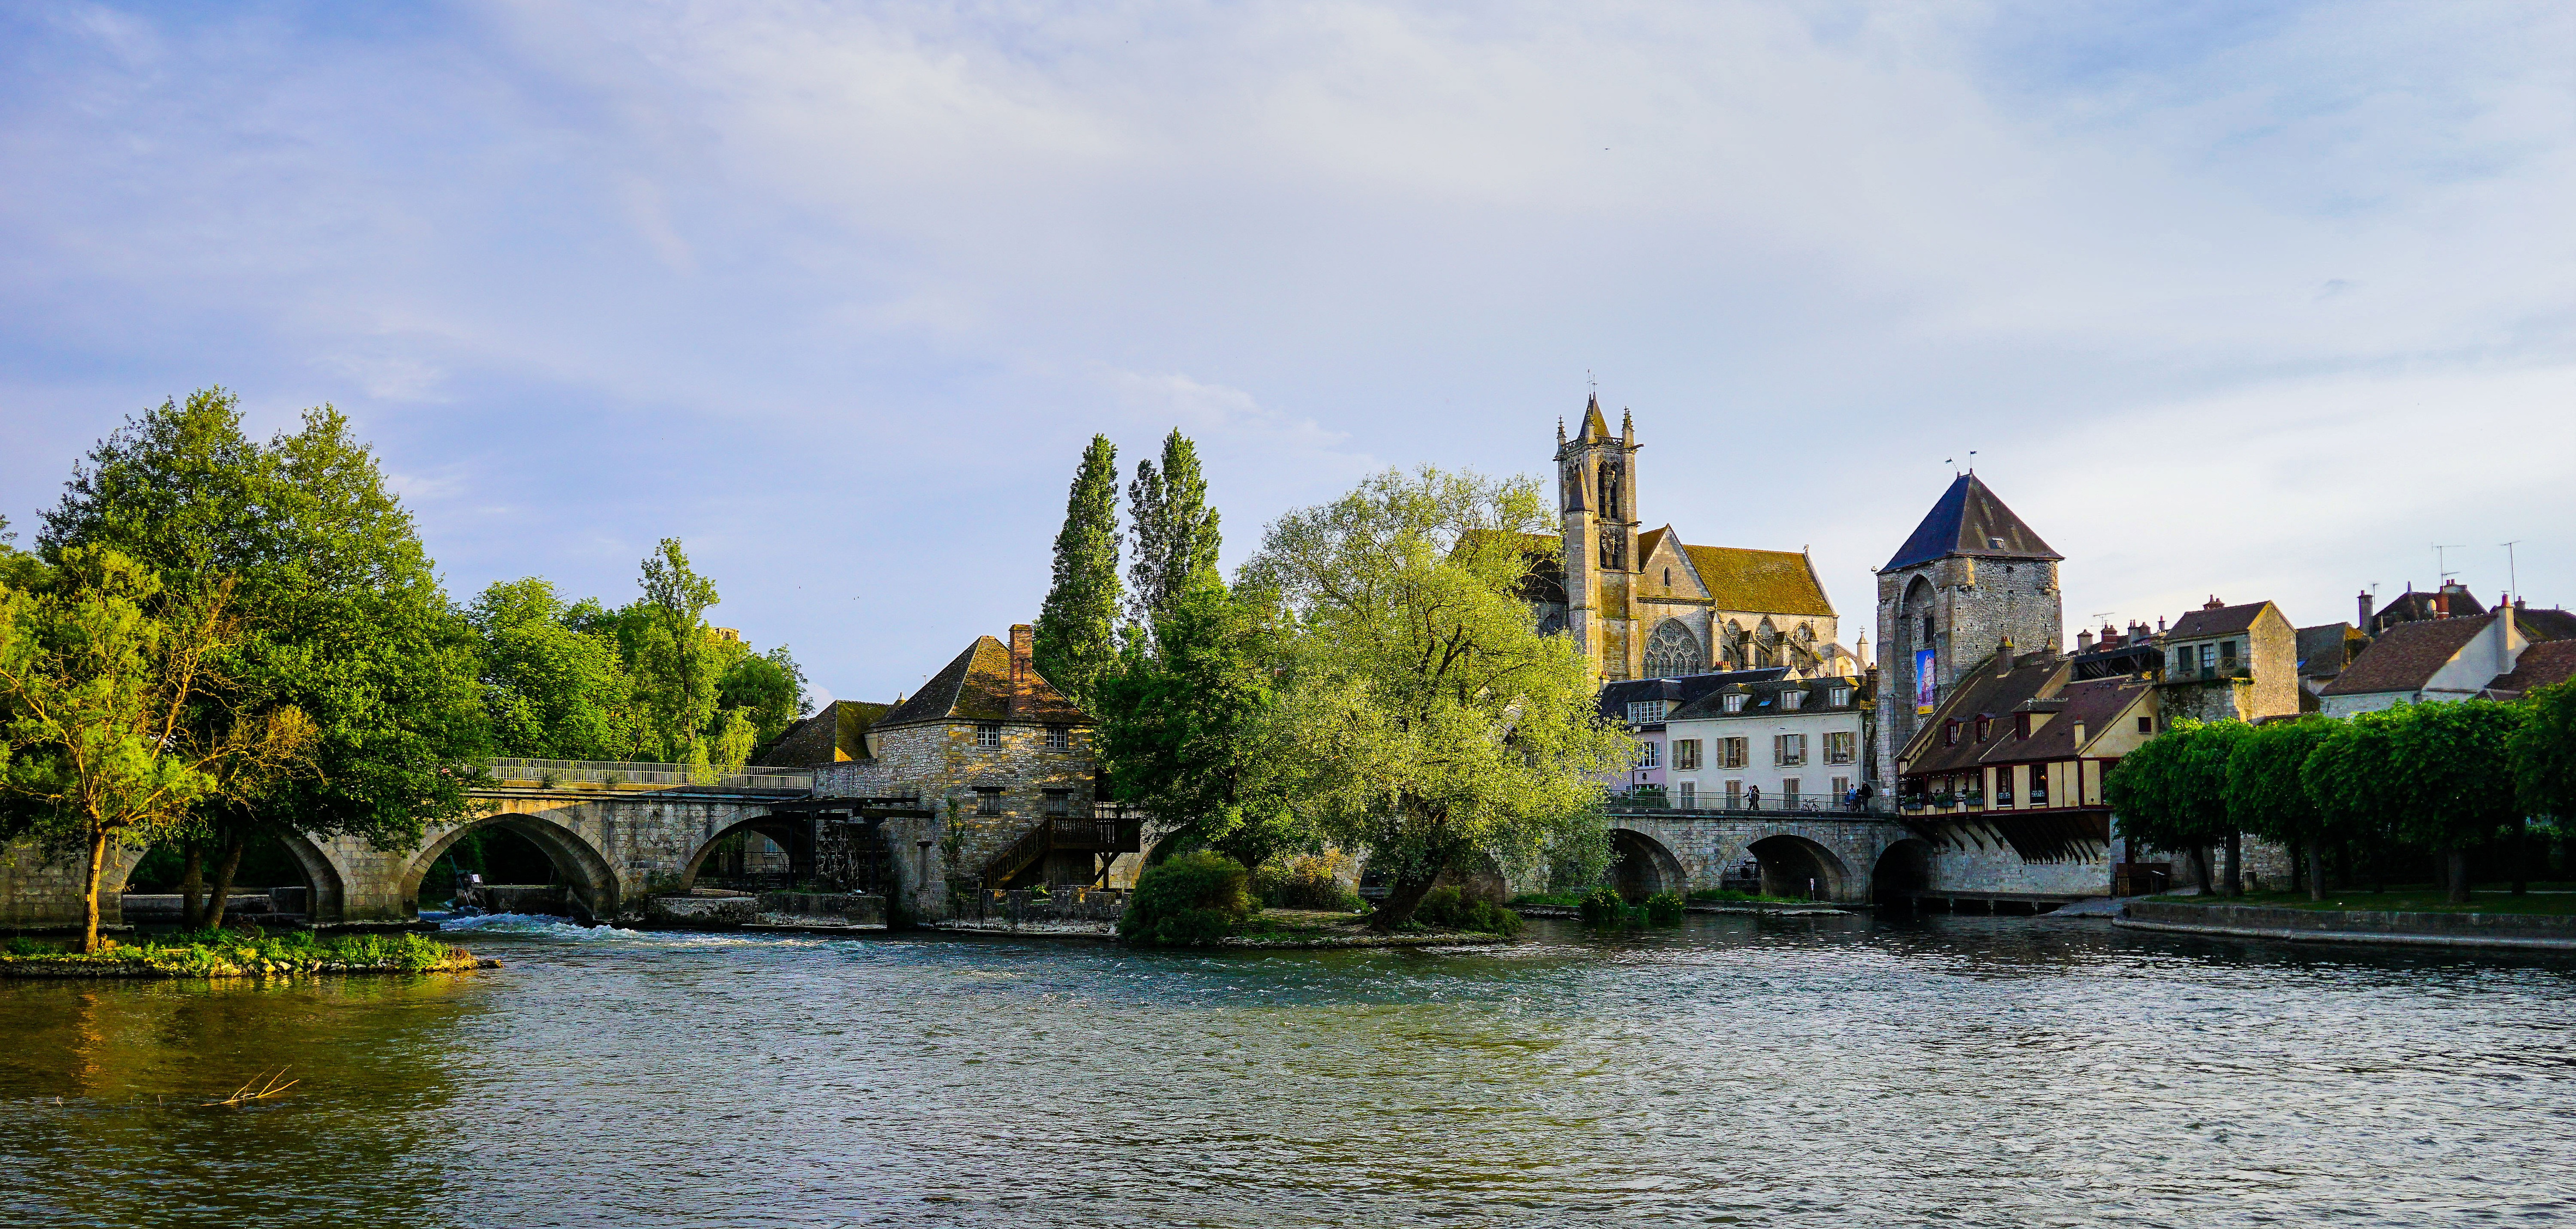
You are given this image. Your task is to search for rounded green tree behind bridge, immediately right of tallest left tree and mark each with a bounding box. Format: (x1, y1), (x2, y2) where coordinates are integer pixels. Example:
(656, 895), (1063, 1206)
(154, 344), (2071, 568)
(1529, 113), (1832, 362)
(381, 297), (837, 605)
(466, 577), (639, 760)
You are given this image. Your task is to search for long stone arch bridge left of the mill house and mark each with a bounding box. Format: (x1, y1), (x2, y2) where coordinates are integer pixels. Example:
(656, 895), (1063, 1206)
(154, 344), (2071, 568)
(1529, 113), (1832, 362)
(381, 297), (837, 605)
(0, 760), (858, 930)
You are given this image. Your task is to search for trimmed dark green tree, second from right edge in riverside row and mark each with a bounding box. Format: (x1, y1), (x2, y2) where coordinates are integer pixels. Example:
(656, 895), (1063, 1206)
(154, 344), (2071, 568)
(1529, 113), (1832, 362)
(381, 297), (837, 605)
(2383, 701), (2522, 905)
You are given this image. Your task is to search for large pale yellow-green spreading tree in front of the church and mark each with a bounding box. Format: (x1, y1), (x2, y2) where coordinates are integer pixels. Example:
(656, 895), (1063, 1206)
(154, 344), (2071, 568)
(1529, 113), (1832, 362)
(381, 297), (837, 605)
(1242, 469), (1633, 927)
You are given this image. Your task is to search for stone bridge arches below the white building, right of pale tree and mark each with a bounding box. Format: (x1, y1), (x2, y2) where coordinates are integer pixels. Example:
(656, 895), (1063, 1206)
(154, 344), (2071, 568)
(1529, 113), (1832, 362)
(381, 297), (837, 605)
(1610, 806), (1932, 905)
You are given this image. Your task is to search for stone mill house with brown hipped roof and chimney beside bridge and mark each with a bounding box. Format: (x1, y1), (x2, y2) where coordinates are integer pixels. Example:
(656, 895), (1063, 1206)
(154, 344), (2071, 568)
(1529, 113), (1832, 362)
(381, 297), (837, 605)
(780, 624), (1136, 917)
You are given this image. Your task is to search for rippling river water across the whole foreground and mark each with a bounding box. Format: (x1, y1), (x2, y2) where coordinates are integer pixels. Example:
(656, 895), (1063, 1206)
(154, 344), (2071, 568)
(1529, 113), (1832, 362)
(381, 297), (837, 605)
(0, 917), (2576, 1229)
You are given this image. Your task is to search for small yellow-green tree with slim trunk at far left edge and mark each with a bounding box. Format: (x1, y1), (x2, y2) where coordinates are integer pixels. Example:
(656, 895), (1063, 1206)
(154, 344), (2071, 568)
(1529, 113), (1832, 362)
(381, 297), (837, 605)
(0, 546), (314, 951)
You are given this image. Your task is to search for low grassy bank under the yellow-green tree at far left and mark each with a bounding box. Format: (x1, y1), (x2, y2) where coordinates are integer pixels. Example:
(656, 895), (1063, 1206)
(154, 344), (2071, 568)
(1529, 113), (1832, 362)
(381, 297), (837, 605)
(0, 930), (479, 977)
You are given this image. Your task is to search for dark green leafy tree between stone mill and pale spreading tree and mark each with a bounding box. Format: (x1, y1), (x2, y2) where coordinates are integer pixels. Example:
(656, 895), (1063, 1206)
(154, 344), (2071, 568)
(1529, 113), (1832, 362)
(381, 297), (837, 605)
(1092, 569), (1309, 871)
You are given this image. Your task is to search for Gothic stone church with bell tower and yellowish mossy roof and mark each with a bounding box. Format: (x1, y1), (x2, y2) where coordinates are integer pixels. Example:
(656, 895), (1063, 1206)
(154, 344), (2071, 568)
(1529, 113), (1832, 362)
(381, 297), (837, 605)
(1525, 397), (1868, 683)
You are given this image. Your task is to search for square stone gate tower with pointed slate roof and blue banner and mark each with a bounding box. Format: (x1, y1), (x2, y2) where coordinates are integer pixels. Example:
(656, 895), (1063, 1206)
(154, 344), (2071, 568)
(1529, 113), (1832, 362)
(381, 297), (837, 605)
(1878, 472), (2066, 781)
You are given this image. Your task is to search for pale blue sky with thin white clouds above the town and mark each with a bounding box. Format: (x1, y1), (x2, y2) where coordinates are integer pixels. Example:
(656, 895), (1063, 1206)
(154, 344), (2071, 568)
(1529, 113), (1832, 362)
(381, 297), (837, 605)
(0, 0), (2576, 698)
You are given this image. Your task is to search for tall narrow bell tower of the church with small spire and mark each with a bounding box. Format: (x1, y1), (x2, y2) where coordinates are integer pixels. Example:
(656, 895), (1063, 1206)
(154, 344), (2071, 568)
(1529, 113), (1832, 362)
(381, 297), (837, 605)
(1556, 394), (1644, 680)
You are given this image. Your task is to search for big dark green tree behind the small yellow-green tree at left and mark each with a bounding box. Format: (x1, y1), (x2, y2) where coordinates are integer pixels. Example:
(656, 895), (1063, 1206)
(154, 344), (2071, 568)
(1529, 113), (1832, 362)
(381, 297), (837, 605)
(39, 389), (487, 925)
